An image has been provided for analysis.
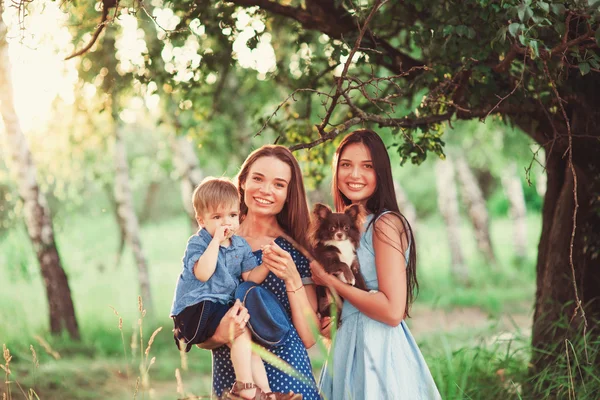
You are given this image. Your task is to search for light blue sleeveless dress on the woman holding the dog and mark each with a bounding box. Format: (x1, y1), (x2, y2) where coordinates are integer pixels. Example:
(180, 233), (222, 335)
(320, 215), (441, 400)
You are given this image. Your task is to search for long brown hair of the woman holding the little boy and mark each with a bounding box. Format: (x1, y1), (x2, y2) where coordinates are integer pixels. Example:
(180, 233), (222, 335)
(237, 145), (310, 252)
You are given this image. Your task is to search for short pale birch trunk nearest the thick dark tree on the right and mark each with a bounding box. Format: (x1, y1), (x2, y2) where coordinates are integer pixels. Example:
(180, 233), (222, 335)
(502, 162), (527, 260)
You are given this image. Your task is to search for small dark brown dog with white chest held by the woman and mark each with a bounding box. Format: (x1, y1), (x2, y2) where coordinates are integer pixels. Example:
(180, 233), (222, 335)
(311, 203), (367, 317)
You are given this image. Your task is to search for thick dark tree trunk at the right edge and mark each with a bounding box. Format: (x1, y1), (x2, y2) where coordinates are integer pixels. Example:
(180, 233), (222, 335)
(531, 124), (600, 398)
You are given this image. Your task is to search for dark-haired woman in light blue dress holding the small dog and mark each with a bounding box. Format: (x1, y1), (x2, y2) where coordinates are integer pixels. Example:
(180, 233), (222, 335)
(311, 129), (440, 400)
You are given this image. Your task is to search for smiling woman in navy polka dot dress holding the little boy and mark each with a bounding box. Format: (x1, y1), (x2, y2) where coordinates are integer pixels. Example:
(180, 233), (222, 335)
(200, 145), (320, 400)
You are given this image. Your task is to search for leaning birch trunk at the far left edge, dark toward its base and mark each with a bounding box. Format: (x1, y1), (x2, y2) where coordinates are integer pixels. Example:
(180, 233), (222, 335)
(0, 10), (80, 339)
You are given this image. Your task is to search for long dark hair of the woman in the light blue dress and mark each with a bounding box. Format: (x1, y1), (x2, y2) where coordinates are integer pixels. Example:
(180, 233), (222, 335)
(331, 129), (419, 317)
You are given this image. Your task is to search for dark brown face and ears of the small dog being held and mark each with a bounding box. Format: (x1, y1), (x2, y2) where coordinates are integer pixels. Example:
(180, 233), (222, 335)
(313, 203), (361, 247)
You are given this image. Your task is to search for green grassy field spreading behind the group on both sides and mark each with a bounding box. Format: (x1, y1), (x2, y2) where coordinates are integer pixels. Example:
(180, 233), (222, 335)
(0, 211), (540, 399)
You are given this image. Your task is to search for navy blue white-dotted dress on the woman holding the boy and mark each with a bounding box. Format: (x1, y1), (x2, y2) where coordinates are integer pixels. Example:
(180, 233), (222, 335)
(212, 237), (321, 400)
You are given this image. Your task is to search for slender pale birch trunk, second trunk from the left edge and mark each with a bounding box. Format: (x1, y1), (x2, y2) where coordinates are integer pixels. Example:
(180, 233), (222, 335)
(112, 106), (154, 315)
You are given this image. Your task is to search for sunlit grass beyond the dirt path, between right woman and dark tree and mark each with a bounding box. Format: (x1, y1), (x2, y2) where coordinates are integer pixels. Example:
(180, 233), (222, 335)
(416, 215), (541, 314)
